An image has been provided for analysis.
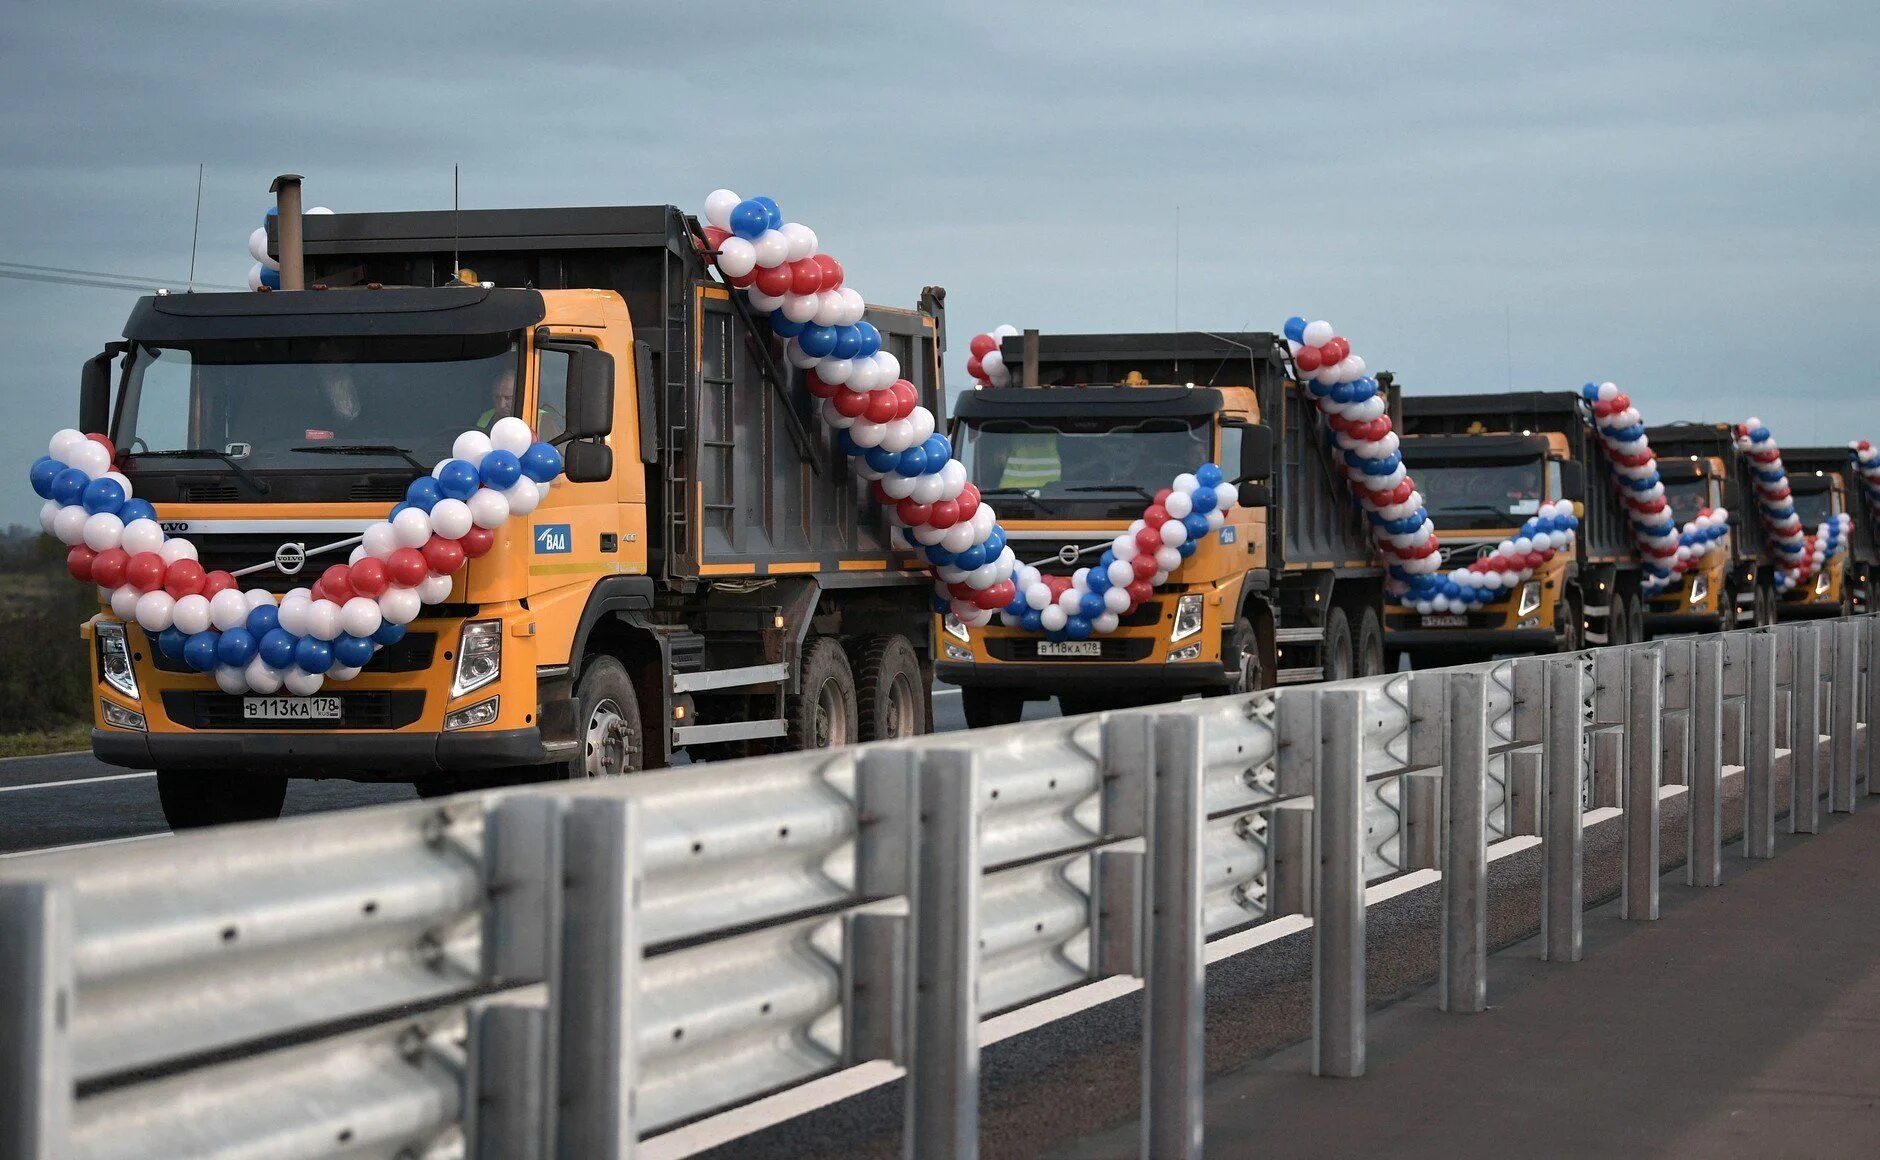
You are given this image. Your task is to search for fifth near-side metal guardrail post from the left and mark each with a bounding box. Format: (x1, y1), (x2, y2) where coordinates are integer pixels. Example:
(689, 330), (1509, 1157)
(1312, 690), (1365, 1077)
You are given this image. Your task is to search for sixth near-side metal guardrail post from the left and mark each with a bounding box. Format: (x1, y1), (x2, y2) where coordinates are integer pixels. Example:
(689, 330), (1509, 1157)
(1440, 671), (1489, 1011)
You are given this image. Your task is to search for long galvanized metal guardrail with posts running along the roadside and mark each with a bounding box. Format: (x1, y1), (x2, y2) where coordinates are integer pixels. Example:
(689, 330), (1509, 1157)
(0, 617), (1880, 1158)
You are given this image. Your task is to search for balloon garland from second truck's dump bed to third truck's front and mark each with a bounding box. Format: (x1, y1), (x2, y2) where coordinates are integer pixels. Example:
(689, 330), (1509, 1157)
(1284, 314), (1579, 613)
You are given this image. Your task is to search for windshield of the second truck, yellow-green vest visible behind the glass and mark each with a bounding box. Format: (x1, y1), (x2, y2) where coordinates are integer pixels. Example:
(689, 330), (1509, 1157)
(961, 415), (1209, 509)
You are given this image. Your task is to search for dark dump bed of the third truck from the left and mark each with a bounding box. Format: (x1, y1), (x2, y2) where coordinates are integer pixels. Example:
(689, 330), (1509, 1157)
(1402, 391), (1637, 562)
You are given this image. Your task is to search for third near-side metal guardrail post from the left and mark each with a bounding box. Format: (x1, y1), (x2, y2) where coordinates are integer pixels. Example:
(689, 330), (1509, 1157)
(902, 748), (979, 1160)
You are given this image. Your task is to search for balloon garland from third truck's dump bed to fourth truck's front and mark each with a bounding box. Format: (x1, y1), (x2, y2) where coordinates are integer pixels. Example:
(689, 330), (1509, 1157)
(1579, 384), (1730, 596)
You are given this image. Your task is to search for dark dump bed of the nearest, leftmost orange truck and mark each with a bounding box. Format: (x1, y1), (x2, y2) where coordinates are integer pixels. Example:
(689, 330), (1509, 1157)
(295, 205), (942, 583)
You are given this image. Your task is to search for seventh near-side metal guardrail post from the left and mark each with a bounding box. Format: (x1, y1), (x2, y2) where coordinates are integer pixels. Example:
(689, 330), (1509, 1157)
(1540, 656), (1585, 963)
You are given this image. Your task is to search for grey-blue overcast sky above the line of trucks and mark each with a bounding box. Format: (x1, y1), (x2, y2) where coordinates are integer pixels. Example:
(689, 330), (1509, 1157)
(0, 0), (1880, 523)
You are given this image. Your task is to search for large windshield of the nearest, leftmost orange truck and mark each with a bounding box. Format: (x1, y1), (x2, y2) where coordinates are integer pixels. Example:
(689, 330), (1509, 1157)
(113, 335), (521, 470)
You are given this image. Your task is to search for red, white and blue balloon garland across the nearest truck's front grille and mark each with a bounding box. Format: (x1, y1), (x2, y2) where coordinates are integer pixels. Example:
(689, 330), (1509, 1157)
(28, 417), (562, 696)
